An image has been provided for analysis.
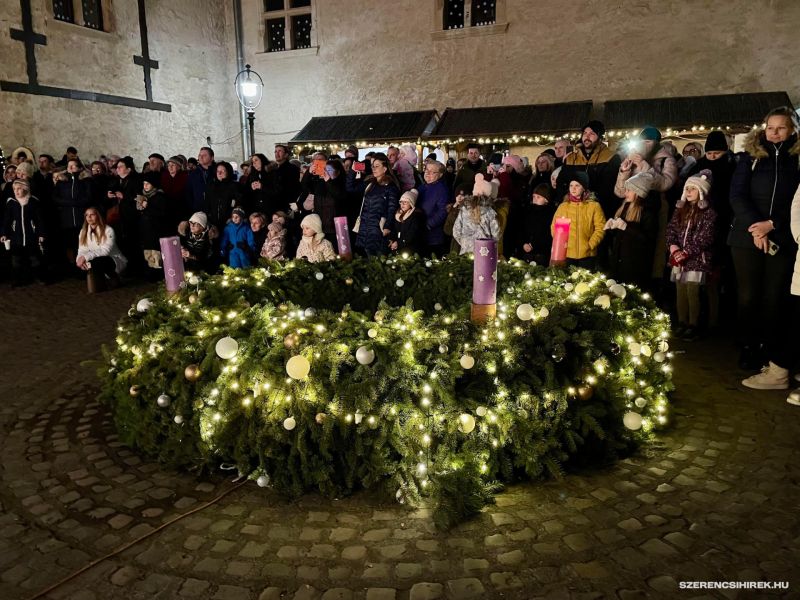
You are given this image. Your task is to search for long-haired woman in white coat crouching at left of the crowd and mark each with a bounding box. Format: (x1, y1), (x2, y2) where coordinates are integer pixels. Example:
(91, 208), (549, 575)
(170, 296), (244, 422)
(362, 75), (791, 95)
(75, 206), (128, 294)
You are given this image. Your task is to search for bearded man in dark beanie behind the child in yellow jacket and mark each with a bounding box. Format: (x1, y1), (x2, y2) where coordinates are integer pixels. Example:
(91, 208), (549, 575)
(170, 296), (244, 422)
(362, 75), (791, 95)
(557, 121), (622, 218)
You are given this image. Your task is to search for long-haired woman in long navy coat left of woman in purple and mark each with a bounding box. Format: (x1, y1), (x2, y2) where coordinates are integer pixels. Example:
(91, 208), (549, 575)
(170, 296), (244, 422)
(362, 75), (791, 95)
(347, 152), (400, 256)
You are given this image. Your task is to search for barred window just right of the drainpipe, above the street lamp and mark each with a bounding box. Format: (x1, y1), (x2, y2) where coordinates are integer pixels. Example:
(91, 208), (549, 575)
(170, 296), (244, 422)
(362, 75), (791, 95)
(264, 0), (314, 52)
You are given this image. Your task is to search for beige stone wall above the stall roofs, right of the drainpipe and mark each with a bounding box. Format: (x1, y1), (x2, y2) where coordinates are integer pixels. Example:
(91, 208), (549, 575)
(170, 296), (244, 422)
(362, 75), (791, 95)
(243, 0), (800, 155)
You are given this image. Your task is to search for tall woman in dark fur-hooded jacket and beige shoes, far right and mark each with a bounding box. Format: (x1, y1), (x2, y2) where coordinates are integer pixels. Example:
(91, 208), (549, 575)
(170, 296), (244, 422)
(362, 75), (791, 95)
(728, 107), (800, 390)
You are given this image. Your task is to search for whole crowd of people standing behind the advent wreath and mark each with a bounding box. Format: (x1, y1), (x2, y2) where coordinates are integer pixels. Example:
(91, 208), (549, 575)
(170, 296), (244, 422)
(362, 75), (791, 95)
(0, 108), (800, 405)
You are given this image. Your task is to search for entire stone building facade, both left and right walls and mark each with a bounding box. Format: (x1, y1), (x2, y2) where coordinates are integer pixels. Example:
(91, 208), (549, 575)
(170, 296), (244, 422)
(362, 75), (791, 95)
(0, 0), (800, 162)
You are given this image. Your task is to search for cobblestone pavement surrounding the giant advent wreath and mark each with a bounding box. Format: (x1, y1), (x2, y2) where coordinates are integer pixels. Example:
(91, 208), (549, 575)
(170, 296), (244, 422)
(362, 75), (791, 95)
(0, 282), (800, 600)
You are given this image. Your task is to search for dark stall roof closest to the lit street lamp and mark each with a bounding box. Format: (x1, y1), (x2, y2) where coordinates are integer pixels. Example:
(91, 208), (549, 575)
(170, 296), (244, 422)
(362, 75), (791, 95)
(290, 110), (439, 143)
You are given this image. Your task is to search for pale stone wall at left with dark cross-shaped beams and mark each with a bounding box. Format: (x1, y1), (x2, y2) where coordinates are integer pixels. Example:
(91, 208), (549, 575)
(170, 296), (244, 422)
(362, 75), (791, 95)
(0, 0), (242, 164)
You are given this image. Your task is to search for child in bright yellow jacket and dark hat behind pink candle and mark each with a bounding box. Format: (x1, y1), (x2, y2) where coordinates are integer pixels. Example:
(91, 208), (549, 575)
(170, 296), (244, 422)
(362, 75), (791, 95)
(550, 171), (606, 270)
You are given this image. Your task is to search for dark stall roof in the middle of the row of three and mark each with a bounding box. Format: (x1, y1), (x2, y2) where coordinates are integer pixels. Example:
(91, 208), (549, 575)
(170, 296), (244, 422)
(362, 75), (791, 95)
(431, 100), (592, 139)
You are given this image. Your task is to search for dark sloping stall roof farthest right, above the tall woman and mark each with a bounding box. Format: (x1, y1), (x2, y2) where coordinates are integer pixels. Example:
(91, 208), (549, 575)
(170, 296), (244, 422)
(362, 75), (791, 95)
(603, 92), (792, 129)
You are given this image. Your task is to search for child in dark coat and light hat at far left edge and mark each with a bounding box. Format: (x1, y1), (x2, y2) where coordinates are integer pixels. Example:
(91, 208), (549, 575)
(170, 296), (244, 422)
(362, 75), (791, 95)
(0, 179), (45, 287)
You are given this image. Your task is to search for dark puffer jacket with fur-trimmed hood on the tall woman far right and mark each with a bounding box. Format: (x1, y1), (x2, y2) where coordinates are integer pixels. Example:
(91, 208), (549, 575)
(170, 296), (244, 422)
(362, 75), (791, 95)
(728, 130), (800, 253)
